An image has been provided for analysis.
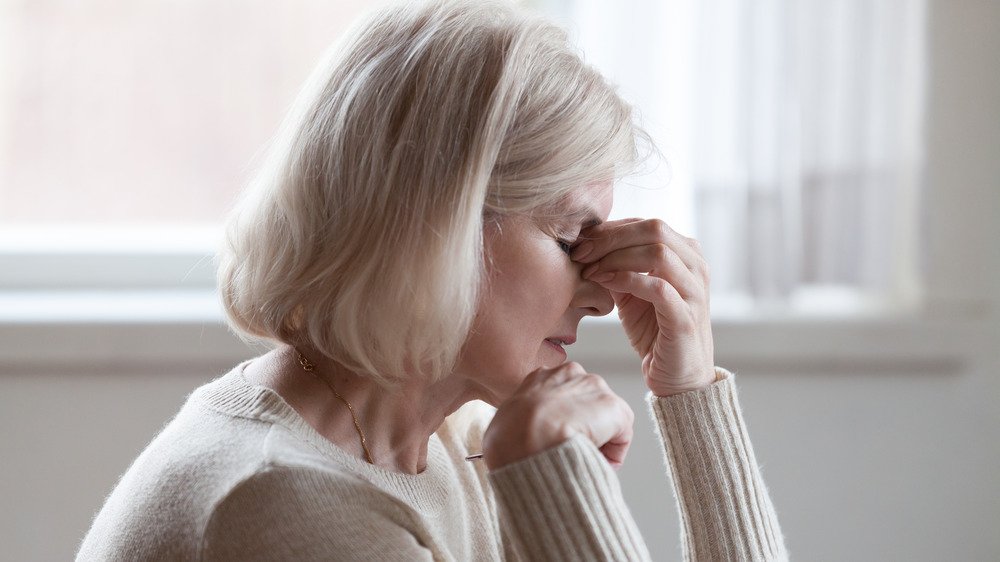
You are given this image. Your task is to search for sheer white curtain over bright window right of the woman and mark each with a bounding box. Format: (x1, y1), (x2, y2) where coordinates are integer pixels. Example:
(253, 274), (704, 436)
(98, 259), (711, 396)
(536, 0), (925, 312)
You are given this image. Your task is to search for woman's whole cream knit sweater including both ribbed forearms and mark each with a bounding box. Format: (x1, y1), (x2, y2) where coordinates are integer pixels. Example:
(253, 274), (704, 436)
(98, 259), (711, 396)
(77, 363), (787, 561)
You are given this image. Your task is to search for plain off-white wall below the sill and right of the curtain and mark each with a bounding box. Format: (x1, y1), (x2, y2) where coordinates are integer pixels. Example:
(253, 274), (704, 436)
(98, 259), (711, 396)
(0, 0), (1000, 561)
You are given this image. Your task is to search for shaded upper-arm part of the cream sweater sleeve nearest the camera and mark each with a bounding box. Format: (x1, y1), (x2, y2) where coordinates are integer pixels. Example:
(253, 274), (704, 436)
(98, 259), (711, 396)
(200, 467), (433, 562)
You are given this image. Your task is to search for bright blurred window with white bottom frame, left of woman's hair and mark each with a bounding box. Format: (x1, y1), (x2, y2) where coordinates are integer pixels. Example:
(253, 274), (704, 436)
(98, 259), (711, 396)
(0, 0), (370, 322)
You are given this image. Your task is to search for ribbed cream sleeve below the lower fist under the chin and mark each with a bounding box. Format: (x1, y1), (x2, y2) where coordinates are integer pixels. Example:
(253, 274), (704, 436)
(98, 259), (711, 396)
(489, 435), (649, 561)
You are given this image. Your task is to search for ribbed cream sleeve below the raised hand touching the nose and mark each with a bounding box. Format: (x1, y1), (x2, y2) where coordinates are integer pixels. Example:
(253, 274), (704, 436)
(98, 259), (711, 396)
(647, 369), (788, 560)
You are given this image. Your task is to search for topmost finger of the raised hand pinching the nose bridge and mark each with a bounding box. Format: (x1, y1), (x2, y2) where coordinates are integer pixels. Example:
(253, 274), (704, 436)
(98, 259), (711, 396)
(570, 219), (708, 283)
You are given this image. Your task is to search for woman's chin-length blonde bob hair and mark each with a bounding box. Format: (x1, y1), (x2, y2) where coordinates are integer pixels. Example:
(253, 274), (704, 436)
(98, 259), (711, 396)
(218, 1), (642, 386)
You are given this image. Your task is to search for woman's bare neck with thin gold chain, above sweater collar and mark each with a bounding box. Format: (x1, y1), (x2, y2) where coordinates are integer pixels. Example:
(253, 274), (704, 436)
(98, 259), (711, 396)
(261, 347), (477, 474)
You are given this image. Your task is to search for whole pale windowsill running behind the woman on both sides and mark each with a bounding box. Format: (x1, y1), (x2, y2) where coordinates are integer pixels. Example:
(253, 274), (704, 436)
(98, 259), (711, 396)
(0, 290), (988, 374)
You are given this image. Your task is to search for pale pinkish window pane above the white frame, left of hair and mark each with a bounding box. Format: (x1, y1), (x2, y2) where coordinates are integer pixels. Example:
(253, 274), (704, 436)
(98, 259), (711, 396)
(0, 0), (372, 226)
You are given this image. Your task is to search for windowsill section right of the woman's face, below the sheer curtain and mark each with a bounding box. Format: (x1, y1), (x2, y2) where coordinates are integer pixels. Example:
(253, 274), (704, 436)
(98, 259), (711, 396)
(570, 308), (988, 374)
